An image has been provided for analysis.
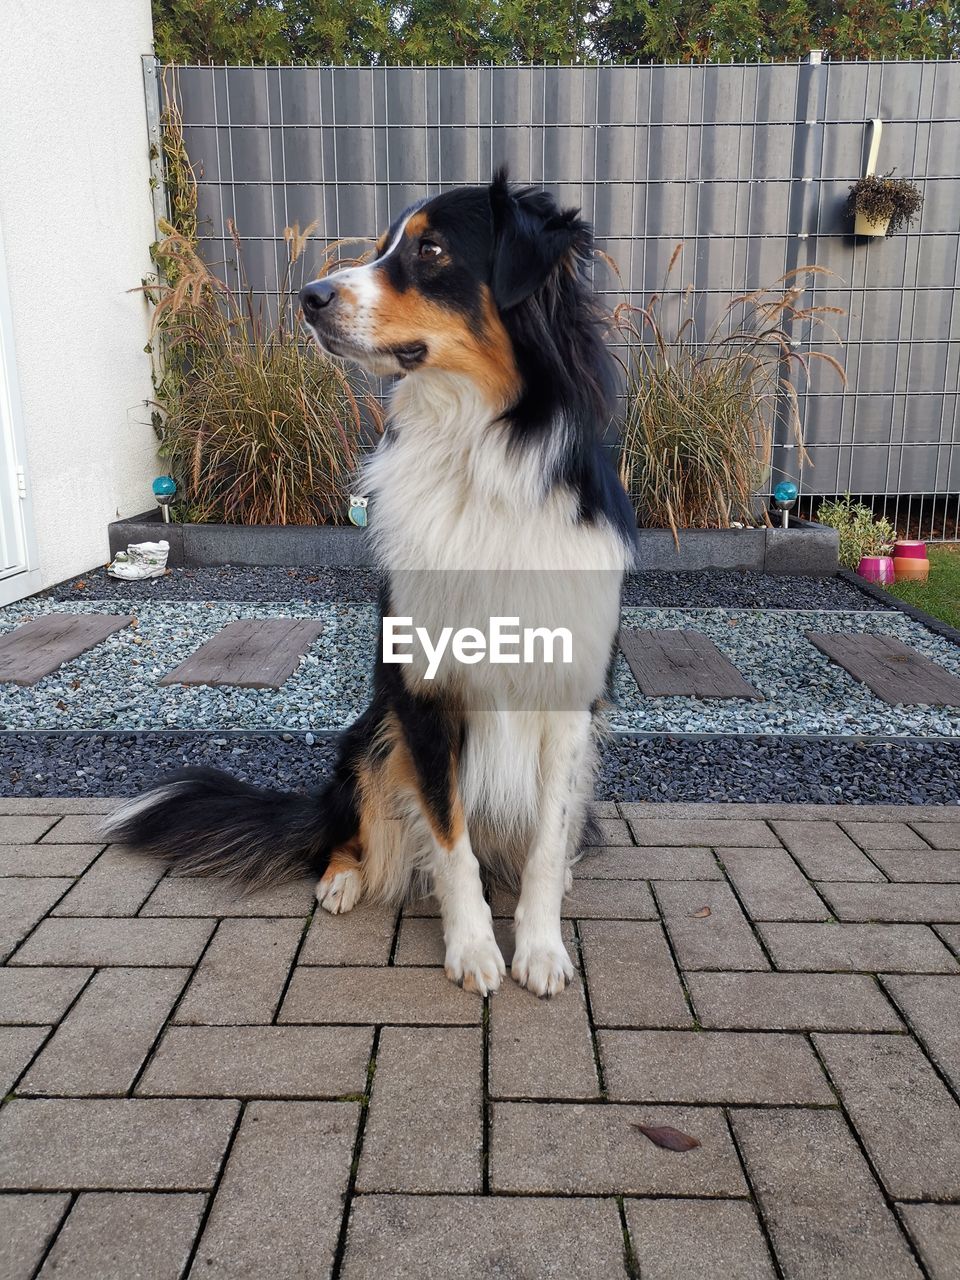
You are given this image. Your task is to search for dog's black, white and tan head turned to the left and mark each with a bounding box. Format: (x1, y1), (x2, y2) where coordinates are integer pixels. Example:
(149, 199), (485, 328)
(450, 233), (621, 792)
(300, 172), (591, 408)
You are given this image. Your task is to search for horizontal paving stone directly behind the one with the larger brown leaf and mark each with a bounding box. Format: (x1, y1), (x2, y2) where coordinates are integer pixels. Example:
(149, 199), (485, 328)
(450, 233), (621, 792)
(599, 1030), (835, 1106)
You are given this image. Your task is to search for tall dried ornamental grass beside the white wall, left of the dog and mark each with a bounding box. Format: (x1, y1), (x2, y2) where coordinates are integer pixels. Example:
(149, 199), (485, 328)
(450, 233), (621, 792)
(145, 224), (379, 525)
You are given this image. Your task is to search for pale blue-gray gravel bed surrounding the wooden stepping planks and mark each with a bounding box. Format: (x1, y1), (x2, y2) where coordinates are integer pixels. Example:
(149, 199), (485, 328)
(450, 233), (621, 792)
(0, 598), (960, 737)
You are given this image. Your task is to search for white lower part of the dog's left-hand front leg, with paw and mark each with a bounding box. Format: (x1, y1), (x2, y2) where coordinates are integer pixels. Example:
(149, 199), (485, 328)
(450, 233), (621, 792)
(430, 827), (507, 996)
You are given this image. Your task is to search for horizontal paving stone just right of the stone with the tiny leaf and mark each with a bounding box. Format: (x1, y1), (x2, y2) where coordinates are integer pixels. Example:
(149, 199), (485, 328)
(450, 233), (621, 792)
(759, 924), (959, 973)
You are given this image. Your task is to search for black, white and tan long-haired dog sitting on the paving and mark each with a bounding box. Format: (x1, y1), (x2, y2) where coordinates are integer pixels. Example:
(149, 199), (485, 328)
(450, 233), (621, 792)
(109, 170), (636, 996)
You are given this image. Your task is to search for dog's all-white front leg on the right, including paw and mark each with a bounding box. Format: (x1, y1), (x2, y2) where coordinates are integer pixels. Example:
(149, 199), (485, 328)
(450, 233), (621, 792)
(511, 712), (591, 996)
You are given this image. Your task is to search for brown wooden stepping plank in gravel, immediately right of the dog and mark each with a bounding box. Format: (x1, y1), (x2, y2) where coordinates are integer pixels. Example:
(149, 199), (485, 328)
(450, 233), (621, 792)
(620, 631), (763, 701)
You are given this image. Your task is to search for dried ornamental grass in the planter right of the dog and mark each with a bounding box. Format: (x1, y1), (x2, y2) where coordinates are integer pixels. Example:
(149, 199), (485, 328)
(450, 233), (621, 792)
(614, 246), (845, 541)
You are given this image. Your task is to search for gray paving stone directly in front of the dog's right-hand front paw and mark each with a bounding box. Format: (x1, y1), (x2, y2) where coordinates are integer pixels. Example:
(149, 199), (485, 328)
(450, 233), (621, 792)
(489, 940), (599, 1098)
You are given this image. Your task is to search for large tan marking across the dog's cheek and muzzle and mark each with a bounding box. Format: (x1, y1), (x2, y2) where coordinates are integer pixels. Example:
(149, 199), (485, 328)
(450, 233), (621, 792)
(370, 278), (520, 413)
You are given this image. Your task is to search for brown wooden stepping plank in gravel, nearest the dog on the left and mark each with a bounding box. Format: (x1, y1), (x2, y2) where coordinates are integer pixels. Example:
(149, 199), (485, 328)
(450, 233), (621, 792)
(160, 618), (324, 689)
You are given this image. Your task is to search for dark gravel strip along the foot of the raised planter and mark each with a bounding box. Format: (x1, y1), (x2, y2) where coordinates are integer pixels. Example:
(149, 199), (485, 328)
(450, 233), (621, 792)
(44, 566), (896, 612)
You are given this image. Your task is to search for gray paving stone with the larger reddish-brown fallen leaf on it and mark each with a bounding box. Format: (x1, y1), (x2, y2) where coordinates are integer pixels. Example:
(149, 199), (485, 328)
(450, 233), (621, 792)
(490, 1102), (746, 1196)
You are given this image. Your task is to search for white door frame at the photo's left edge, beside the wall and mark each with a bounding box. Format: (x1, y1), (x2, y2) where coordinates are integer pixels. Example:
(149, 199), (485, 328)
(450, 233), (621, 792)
(0, 208), (40, 605)
